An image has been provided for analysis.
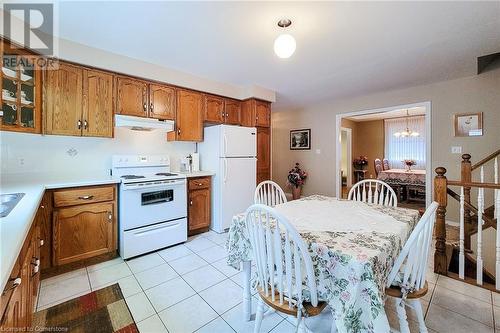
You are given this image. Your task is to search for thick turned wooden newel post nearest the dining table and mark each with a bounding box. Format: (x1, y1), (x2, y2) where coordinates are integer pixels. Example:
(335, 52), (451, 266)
(434, 167), (448, 275)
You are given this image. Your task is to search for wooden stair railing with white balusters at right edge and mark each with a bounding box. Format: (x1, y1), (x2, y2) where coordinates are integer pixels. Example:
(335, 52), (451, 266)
(434, 150), (500, 291)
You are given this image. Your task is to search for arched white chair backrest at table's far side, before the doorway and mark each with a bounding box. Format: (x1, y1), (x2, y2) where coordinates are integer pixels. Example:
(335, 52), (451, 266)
(347, 179), (398, 207)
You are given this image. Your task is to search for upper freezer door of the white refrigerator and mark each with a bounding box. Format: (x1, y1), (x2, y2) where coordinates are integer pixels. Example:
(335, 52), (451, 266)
(220, 125), (257, 157)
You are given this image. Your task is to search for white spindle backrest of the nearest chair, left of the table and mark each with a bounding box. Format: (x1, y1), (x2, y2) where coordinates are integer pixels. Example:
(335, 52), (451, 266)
(246, 204), (318, 309)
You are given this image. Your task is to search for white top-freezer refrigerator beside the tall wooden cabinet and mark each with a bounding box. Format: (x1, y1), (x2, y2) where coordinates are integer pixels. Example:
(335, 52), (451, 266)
(198, 125), (257, 233)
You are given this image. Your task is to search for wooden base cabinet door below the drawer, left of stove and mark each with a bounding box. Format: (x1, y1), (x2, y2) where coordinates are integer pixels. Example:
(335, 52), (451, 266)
(52, 202), (116, 265)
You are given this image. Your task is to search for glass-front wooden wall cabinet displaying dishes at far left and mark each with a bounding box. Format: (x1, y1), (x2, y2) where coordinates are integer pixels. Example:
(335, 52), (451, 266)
(0, 41), (42, 133)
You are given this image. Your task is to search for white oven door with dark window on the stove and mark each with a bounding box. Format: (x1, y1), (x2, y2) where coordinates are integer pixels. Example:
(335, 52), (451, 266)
(119, 179), (187, 230)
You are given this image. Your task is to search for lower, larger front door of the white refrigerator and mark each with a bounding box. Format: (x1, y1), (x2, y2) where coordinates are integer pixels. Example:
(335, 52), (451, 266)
(216, 158), (257, 232)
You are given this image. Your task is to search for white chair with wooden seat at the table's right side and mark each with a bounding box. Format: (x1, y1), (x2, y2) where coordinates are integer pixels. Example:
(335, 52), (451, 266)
(386, 201), (438, 333)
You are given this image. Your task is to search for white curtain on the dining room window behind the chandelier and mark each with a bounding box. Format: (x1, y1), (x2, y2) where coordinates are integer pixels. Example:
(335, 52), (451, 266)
(384, 116), (425, 169)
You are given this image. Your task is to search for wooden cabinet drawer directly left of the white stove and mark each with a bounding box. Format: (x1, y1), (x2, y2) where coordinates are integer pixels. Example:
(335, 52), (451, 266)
(54, 186), (115, 207)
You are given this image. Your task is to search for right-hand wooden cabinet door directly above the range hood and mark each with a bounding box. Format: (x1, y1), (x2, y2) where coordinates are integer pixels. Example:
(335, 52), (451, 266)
(149, 84), (175, 120)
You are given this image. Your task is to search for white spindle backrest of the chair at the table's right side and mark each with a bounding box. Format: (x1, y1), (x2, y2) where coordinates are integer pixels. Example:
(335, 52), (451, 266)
(387, 201), (438, 290)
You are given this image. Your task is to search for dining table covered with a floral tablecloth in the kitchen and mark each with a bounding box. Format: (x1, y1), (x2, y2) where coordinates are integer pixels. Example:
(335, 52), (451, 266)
(226, 195), (419, 333)
